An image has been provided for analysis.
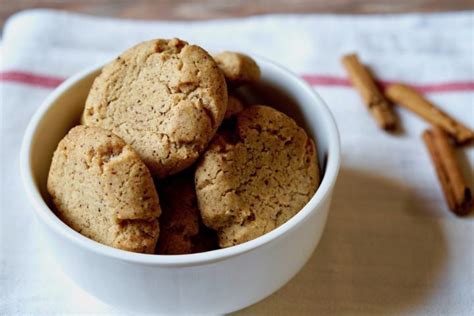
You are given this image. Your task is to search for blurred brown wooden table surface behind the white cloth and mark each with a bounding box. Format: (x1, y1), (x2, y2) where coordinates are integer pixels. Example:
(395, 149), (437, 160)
(0, 0), (474, 28)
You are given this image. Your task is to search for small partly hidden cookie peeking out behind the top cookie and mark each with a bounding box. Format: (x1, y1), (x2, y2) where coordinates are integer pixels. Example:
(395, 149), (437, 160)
(213, 52), (260, 85)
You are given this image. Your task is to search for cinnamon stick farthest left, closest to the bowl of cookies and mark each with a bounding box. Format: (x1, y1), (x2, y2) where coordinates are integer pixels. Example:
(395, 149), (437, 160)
(342, 54), (397, 130)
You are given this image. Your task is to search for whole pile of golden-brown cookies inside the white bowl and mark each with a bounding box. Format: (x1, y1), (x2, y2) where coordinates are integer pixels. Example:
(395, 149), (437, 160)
(47, 39), (320, 254)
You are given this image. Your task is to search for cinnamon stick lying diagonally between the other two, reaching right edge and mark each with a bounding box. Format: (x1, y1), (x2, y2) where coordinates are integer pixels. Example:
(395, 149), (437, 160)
(385, 83), (474, 144)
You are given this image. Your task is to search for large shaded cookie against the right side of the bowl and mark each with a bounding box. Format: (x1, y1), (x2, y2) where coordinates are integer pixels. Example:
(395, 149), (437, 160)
(195, 105), (320, 247)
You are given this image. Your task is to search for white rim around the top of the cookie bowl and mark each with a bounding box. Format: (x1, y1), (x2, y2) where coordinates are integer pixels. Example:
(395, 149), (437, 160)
(20, 55), (341, 267)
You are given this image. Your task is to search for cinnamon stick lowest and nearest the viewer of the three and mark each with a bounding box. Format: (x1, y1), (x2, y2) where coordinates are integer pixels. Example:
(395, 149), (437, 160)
(422, 127), (473, 215)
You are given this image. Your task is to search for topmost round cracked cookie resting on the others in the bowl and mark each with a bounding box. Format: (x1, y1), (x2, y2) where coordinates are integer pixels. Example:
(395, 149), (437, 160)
(83, 39), (227, 178)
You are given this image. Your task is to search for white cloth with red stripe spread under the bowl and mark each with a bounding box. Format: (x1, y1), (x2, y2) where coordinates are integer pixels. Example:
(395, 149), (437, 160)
(0, 10), (474, 315)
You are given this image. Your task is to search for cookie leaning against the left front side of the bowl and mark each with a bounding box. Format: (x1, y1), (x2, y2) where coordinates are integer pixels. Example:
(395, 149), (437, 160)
(47, 126), (160, 253)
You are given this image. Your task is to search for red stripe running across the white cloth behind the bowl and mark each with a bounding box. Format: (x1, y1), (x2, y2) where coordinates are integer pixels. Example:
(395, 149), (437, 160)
(0, 71), (474, 93)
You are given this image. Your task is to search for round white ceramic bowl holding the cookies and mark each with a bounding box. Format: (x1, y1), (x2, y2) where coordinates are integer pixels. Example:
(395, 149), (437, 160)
(21, 57), (340, 314)
